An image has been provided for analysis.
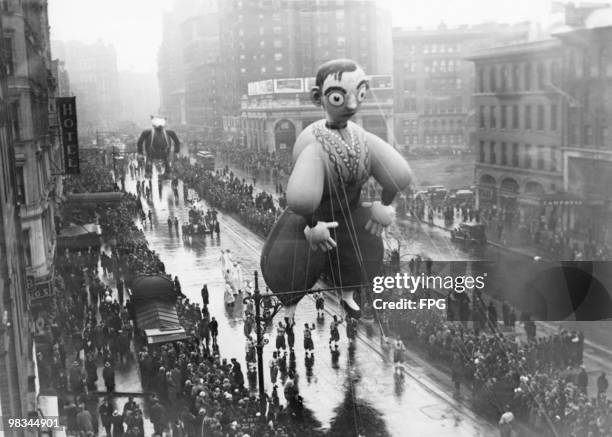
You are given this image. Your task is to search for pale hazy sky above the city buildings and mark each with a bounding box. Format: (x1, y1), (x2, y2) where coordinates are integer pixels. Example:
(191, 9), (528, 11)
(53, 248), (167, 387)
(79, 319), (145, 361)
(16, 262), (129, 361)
(49, 0), (551, 72)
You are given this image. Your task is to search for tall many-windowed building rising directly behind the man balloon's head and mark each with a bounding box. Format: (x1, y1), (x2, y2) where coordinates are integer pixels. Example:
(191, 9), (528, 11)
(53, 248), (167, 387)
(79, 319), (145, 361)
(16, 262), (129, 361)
(219, 0), (392, 115)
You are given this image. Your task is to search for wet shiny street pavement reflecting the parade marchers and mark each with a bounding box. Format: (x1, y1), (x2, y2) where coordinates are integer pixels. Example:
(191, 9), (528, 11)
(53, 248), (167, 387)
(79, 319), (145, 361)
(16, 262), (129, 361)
(127, 166), (496, 437)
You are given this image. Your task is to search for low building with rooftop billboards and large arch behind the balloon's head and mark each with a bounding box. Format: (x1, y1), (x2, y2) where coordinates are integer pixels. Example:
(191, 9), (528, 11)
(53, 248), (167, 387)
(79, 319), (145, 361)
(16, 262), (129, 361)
(239, 75), (393, 155)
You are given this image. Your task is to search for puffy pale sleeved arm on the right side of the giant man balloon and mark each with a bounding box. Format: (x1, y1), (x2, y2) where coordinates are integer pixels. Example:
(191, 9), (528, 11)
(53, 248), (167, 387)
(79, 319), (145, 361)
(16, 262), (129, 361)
(366, 133), (413, 194)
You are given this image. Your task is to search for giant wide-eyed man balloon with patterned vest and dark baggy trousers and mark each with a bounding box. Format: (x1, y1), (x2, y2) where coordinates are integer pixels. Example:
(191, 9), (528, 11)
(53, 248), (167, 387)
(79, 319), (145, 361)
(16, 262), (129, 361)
(261, 59), (412, 318)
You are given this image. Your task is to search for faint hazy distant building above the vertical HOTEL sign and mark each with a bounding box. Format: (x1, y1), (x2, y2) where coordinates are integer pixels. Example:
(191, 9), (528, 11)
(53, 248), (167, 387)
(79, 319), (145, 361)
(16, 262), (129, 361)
(53, 41), (121, 134)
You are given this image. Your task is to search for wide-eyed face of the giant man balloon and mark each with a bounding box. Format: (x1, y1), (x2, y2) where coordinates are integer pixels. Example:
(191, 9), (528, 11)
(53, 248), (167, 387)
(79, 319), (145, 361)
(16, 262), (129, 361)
(321, 67), (368, 123)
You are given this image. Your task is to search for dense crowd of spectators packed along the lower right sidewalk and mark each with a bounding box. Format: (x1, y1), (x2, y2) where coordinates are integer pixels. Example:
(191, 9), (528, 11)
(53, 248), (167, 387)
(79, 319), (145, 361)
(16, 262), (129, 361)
(377, 280), (612, 437)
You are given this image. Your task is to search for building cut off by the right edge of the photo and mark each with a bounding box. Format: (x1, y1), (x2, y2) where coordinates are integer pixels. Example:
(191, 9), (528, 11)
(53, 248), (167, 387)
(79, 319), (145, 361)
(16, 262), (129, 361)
(555, 23), (612, 254)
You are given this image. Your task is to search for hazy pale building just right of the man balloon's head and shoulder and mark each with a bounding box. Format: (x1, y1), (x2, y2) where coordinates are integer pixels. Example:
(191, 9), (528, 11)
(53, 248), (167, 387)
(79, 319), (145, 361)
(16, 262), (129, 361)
(393, 24), (529, 151)
